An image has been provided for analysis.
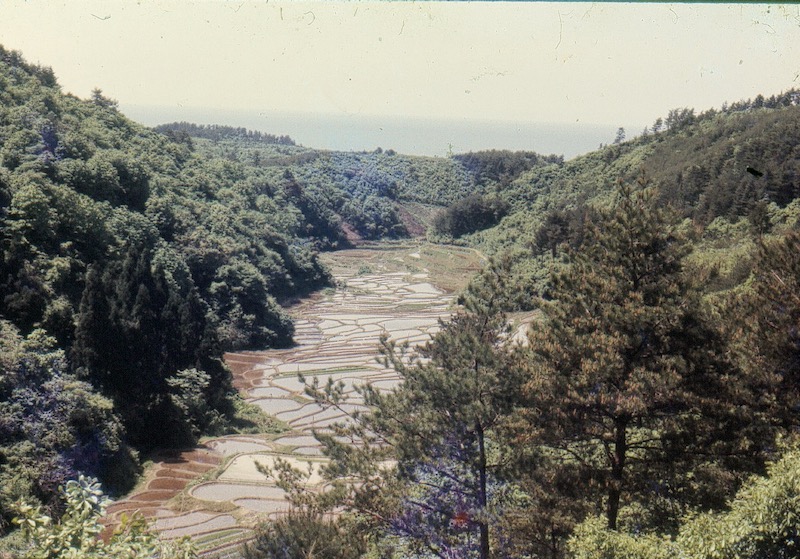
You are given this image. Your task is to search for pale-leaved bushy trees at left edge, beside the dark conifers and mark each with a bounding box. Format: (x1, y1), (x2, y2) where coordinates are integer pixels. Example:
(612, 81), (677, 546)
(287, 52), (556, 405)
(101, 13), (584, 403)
(0, 321), (138, 527)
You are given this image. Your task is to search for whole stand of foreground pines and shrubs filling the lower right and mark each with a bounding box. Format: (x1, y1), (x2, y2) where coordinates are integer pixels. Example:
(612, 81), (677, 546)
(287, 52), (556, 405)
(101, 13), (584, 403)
(277, 183), (800, 559)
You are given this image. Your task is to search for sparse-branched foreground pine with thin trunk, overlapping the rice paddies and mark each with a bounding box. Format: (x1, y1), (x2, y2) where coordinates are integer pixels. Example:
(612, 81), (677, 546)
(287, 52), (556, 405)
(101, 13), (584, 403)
(296, 258), (522, 559)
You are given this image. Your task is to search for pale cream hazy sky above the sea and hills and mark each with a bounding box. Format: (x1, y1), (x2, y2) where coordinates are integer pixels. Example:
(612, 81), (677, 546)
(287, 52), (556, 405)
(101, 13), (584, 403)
(0, 0), (800, 128)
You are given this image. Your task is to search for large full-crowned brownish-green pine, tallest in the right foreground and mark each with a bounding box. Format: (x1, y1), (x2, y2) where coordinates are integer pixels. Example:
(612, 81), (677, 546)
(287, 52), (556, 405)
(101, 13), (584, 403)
(526, 179), (736, 529)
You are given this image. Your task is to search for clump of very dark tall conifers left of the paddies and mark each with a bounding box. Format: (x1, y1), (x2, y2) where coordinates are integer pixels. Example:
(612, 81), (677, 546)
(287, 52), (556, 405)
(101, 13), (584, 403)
(72, 245), (230, 446)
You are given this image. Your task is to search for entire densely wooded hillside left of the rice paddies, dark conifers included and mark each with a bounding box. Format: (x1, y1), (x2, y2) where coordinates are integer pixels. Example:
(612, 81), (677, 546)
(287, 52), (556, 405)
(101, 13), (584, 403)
(0, 49), (366, 530)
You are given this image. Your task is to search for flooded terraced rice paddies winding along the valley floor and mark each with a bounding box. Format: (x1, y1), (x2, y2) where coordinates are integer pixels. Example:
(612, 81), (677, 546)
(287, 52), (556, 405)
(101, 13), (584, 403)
(104, 245), (479, 557)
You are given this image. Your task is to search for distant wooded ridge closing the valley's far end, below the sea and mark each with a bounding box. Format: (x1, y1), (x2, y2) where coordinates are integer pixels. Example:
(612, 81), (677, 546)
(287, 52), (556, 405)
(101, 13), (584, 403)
(156, 122), (563, 243)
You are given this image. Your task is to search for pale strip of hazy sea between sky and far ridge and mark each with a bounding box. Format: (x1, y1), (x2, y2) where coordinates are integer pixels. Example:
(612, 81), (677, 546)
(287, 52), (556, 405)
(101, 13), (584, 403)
(120, 105), (644, 159)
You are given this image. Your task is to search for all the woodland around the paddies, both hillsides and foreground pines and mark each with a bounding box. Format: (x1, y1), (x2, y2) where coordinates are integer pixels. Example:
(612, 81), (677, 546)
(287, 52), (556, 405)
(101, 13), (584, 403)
(0, 47), (800, 559)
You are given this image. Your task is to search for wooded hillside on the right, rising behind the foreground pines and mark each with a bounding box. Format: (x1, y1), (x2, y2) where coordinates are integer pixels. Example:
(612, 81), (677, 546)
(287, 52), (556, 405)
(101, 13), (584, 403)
(443, 90), (800, 302)
